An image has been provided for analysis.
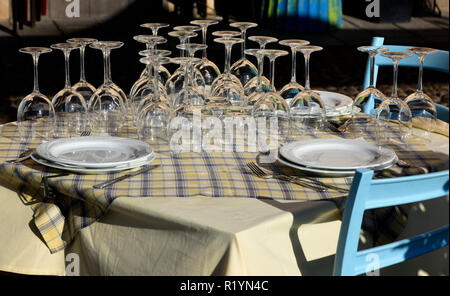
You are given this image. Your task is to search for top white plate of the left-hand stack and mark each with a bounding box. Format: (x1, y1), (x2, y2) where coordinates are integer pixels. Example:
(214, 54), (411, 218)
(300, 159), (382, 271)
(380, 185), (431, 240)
(36, 137), (154, 169)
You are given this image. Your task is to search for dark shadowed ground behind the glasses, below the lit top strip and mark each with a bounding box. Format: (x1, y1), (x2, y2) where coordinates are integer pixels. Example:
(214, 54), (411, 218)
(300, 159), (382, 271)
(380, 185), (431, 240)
(0, 7), (449, 123)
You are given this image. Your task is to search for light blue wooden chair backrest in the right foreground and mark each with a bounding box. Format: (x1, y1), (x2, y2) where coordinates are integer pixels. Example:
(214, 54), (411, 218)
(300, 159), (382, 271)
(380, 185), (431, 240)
(333, 170), (449, 276)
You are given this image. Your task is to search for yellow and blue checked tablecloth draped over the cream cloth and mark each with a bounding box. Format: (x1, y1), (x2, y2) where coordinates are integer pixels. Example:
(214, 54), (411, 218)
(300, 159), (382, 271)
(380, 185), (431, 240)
(0, 123), (448, 253)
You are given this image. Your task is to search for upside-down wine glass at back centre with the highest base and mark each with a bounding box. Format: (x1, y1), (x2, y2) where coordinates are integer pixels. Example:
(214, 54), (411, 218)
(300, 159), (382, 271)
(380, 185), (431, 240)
(191, 20), (220, 93)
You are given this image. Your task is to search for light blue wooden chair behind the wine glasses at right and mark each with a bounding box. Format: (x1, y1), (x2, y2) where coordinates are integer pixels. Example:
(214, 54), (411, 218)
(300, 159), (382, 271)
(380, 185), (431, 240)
(363, 37), (449, 122)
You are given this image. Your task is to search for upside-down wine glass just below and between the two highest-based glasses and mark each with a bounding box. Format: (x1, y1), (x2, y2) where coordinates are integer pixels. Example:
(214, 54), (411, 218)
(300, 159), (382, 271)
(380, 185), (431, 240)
(211, 38), (247, 106)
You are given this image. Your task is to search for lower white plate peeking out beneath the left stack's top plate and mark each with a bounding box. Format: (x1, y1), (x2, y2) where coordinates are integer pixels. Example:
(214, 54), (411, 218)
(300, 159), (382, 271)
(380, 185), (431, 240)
(31, 153), (155, 175)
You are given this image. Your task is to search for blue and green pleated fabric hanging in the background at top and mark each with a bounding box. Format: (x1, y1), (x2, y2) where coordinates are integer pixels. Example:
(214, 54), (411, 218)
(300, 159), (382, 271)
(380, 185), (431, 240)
(261, 0), (343, 32)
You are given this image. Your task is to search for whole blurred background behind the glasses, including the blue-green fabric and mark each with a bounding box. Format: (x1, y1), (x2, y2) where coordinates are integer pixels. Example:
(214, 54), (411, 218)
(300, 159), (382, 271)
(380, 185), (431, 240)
(0, 0), (449, 124)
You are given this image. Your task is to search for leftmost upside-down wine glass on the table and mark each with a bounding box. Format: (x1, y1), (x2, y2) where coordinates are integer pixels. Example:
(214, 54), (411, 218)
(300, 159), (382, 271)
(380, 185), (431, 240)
(17, 47), (56, 140)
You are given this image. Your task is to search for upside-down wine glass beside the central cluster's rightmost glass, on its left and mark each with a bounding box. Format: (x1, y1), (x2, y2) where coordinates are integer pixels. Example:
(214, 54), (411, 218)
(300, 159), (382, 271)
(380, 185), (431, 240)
(279, 39), (309, 104)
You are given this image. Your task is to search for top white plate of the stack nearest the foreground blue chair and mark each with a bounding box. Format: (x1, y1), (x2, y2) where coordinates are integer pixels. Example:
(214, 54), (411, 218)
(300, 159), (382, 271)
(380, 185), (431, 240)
(280, 139), (397, 171)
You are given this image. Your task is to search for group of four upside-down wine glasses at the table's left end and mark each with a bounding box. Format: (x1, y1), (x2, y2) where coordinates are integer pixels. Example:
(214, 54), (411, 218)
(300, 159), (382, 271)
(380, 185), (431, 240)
(17, 38), (127, 138)
